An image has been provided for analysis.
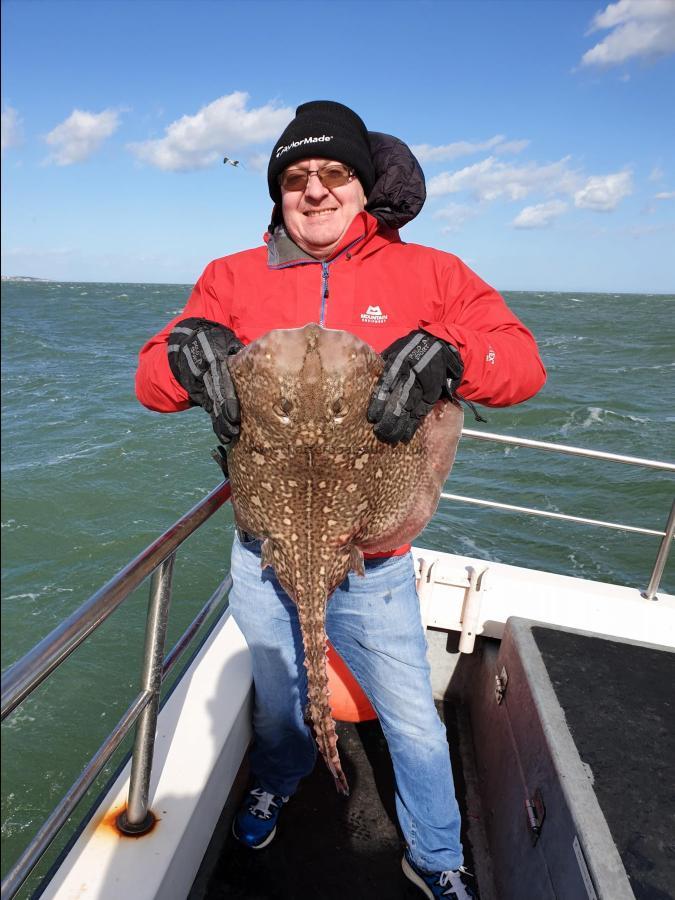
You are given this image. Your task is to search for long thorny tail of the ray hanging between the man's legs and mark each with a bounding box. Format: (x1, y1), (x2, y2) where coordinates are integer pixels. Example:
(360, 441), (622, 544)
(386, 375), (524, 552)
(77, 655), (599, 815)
(298, 599), (349, 796)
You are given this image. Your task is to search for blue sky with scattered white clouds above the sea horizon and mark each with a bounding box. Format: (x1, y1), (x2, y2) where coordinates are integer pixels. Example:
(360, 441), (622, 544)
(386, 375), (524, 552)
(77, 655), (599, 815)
(2, 0), (675, 293)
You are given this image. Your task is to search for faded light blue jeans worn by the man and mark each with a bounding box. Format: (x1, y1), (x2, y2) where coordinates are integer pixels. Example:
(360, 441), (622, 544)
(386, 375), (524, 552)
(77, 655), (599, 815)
(230, 537), (462, 872)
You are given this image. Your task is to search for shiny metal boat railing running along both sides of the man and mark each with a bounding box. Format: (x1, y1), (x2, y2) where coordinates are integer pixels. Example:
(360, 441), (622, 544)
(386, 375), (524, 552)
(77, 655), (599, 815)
(2, 429), (675, 900)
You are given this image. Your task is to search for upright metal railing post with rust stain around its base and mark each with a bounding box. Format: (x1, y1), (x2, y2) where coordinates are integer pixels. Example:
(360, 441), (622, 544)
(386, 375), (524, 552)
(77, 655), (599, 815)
(117, 553), (176, 834)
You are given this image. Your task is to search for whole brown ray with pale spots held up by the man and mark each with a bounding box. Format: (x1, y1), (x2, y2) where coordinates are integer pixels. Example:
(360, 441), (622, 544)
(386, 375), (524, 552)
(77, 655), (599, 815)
(228, 324), (463, 794)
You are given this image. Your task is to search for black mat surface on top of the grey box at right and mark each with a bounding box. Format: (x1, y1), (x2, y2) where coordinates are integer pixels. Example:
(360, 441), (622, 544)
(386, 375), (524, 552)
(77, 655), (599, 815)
(532, 627), (675, 900)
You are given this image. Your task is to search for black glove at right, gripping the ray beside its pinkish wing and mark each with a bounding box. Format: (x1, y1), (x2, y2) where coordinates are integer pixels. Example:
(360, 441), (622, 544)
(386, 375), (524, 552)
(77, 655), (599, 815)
(367, 331), (464, 444)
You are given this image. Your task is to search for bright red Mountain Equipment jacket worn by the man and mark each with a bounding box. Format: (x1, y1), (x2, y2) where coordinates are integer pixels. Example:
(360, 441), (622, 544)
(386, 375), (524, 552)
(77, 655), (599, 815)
(136, 212), (546, 412)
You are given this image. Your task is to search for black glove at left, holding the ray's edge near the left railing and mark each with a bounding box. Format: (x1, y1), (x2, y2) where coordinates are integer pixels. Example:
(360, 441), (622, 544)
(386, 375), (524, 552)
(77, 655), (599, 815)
(168, 319), (244, 444)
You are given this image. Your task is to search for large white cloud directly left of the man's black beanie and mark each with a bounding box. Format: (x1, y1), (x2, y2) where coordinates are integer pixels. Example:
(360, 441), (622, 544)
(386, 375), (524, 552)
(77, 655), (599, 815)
(129, 91), (293, 172)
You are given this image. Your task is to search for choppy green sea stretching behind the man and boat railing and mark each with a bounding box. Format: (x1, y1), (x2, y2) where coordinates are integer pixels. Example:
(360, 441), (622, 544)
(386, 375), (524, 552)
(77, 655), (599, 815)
(2, 281), (675, 874)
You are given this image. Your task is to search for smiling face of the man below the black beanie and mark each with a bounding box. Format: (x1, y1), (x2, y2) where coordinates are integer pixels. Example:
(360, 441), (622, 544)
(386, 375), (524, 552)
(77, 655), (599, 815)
(281, 159), (366, 259)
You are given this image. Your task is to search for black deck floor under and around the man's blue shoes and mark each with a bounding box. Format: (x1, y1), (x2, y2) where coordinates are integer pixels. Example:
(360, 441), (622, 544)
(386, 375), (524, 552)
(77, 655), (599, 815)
(205, 704), (472, 900)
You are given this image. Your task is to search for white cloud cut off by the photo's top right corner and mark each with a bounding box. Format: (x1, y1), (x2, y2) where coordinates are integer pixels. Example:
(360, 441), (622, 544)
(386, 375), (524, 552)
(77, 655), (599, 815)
(581, 0), (675, 66)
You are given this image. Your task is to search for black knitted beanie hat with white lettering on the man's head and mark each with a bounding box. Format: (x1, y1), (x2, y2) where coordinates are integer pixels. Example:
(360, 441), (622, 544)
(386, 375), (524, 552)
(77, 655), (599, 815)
(267, 100), (375, 203)
